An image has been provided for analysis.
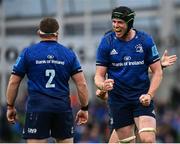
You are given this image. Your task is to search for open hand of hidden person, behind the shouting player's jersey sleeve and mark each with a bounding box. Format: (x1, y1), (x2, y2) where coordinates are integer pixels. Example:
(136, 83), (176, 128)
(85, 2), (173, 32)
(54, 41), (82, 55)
(161, 50), (177, 67)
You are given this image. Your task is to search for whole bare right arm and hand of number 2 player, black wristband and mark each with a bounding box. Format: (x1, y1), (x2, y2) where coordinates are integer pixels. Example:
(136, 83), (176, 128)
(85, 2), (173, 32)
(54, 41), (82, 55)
(72, 72), (89, 124)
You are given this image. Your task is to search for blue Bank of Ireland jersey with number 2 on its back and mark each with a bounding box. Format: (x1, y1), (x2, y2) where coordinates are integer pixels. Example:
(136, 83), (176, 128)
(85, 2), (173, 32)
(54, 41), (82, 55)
(12, 41), (82, 112)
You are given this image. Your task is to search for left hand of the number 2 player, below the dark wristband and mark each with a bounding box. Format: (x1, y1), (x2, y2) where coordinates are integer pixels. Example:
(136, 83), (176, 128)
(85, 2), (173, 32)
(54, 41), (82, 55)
(6, 107), (17, 124)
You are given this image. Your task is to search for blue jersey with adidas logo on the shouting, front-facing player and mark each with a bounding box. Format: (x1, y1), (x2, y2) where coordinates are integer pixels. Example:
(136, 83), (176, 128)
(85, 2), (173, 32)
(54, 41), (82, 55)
(96, 30), (160, 103)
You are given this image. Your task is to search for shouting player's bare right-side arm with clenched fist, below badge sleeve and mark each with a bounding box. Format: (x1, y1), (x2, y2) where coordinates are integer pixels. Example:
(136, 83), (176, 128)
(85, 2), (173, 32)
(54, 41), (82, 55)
(139, 61), (163, 106)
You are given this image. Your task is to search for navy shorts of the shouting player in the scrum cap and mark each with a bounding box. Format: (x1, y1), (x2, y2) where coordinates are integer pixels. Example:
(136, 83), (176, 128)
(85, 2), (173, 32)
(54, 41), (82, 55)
(110, 100), (155, 129)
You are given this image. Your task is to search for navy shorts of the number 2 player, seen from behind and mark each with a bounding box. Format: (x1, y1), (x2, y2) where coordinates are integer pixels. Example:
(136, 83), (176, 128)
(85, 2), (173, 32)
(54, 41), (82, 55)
(23, 112), (74, 140)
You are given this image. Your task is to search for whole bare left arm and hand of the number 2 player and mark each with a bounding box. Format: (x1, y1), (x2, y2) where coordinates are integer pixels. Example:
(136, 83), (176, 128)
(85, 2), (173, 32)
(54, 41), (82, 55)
(6, 74), (22, 123)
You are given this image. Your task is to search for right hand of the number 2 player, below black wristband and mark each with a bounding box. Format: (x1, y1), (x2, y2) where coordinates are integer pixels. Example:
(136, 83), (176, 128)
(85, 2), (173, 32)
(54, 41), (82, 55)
(75, 110), (88, 125)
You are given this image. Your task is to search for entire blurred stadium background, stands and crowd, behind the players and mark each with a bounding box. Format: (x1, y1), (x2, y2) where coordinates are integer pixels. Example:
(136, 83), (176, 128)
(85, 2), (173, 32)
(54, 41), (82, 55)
(0, 0), (180, 143)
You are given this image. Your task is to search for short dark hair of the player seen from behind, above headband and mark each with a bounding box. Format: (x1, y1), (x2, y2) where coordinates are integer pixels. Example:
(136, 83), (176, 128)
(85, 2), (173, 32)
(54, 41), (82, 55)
(39, 17), (59, 34)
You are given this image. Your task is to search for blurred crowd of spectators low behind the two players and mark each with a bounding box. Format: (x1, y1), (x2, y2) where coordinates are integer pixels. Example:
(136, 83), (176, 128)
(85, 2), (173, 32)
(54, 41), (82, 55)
(0, 88), (180, 143)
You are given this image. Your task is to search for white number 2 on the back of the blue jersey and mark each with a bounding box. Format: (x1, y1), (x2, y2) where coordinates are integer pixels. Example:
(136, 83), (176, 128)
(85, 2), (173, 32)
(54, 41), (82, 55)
(46, 69), (55, 88)
